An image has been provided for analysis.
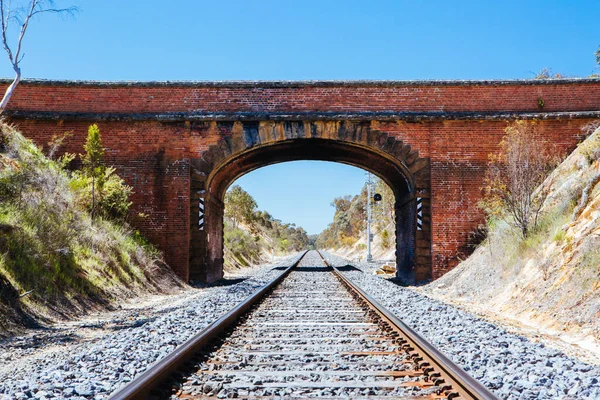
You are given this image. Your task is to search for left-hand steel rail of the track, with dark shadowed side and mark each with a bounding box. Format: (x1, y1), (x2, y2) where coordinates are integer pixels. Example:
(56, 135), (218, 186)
(109, 251), (308, 400)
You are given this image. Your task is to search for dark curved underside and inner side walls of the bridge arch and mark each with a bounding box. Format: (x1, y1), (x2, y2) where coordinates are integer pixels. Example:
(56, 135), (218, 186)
(190, 123), (431, 282)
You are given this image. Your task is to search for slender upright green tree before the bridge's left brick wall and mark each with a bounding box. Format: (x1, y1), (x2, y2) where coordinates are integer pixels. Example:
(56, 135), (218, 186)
(80, 124), (106, 220)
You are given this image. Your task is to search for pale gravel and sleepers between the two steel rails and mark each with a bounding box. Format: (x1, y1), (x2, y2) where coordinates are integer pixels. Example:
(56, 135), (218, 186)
(175, 251), (442, 400)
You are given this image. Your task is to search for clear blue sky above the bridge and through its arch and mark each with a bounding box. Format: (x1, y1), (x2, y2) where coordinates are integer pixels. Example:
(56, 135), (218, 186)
(0, 0), (600, 233)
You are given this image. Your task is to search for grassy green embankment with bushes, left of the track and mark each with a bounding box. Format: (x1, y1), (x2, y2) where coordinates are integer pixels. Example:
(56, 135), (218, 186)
(0, 124), (180, 334)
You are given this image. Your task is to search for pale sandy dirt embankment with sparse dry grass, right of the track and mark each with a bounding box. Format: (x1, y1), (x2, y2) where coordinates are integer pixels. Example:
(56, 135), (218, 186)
(422, 126), (600, 360)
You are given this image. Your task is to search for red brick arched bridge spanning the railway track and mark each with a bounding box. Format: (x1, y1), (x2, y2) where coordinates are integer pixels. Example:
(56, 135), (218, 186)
(0, 79), (600, 281)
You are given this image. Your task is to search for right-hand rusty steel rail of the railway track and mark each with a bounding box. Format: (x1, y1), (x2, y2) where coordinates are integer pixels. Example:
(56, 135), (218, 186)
(317, 250), (499, 400)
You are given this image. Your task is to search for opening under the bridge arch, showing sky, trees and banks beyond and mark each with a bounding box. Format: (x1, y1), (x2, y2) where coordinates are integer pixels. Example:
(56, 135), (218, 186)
(223, 160), (396, 270)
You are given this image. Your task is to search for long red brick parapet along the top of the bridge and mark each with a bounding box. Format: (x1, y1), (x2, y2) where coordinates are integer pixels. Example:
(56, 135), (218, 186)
(0, 79), (600, 115)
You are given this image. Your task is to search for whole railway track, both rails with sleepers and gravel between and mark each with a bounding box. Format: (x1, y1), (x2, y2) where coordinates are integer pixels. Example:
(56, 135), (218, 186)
(111, 251), (496, 399)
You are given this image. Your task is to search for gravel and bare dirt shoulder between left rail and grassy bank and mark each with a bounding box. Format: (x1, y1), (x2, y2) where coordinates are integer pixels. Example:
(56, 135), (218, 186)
(0, 254), (300, 400)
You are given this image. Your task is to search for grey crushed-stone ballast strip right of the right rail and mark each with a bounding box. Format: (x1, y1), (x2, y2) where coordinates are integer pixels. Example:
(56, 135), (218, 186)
(323, 253), (600, 400)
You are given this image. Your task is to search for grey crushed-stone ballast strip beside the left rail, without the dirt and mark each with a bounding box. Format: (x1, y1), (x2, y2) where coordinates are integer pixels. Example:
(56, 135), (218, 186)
(0, 253), (302, 400)
